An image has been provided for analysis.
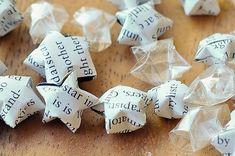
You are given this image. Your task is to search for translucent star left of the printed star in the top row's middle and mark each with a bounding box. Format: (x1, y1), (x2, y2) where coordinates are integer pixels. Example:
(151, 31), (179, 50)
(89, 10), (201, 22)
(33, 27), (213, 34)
(73, 7), (116, 52)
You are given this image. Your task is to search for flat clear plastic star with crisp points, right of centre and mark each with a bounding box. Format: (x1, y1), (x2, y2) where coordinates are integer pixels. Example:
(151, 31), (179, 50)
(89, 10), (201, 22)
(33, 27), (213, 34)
(131, 39), (191, 86)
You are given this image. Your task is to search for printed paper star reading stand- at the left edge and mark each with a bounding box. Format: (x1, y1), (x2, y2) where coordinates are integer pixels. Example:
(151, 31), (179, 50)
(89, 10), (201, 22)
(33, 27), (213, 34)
(0, 75), (44, 128)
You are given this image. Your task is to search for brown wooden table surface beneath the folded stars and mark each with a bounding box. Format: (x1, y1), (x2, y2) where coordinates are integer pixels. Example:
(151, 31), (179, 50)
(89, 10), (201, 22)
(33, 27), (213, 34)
(0, 0), (235, 156)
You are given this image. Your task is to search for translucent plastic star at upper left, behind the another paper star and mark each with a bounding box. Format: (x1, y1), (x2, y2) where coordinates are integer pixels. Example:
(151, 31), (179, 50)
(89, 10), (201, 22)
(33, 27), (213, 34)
(24, 1), (69, 44)
